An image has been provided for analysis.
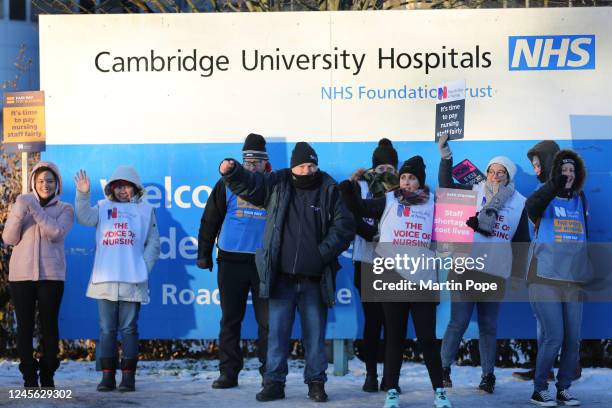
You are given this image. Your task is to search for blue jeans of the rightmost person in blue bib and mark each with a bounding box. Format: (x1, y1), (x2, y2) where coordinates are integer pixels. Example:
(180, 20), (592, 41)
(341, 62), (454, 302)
(529, 283), (583, 391)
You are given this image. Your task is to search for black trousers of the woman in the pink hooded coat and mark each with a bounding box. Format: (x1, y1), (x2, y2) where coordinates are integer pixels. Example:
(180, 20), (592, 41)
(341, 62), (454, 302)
(9, 280), (64, 373)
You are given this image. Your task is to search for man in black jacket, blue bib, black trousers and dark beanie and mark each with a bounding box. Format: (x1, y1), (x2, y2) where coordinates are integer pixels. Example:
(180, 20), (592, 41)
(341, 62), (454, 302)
(197, 133), (270, 388)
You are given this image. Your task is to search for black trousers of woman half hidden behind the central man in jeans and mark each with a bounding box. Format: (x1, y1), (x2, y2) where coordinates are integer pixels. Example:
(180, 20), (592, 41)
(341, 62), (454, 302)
(353, 262), (385, 375)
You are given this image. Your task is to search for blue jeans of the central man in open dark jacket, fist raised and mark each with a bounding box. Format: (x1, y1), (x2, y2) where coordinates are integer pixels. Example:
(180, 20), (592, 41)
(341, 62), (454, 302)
(264, 275), (327, 384)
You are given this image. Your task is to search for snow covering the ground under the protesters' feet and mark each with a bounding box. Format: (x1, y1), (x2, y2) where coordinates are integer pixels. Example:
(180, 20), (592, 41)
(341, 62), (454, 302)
(0, 359), (612, 408)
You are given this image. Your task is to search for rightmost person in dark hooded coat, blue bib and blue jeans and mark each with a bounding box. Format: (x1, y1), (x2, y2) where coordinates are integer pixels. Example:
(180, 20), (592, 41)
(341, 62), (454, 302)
(525, 150), (592, 407)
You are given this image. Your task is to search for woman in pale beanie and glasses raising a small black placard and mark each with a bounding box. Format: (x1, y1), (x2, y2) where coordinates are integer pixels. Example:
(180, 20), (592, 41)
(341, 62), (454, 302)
(438, 136), (529, 394)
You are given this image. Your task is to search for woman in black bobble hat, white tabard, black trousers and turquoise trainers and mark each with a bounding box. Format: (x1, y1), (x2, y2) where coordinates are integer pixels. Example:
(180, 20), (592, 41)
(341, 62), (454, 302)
(340, 156), (451, 408)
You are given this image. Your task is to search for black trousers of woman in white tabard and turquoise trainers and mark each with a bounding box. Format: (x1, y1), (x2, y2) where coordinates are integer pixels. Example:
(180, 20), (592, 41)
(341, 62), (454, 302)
(382, 302), (442, 390)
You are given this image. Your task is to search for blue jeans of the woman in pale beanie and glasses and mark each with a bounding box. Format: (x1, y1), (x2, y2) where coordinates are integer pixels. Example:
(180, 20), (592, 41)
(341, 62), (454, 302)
(441, 301), (499, 374)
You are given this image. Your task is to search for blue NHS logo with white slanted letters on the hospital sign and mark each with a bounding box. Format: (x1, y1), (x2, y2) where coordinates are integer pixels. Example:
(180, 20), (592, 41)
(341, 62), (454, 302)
(508, 35), (595, 71)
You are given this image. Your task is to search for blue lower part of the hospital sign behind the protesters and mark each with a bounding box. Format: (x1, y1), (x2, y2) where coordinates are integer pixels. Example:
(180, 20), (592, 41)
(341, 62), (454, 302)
(43, 133), (612, 339)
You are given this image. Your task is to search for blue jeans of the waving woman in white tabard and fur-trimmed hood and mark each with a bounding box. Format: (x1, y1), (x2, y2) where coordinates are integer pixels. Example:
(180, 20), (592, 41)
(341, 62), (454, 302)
(96, 299), (140, 359)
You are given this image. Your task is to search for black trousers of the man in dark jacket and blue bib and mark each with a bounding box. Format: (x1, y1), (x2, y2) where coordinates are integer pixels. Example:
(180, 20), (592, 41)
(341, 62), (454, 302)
(217, 259), (268, 377)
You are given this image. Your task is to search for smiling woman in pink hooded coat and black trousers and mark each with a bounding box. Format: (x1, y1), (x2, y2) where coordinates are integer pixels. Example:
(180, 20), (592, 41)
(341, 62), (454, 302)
(2, 161), (74, 388)
